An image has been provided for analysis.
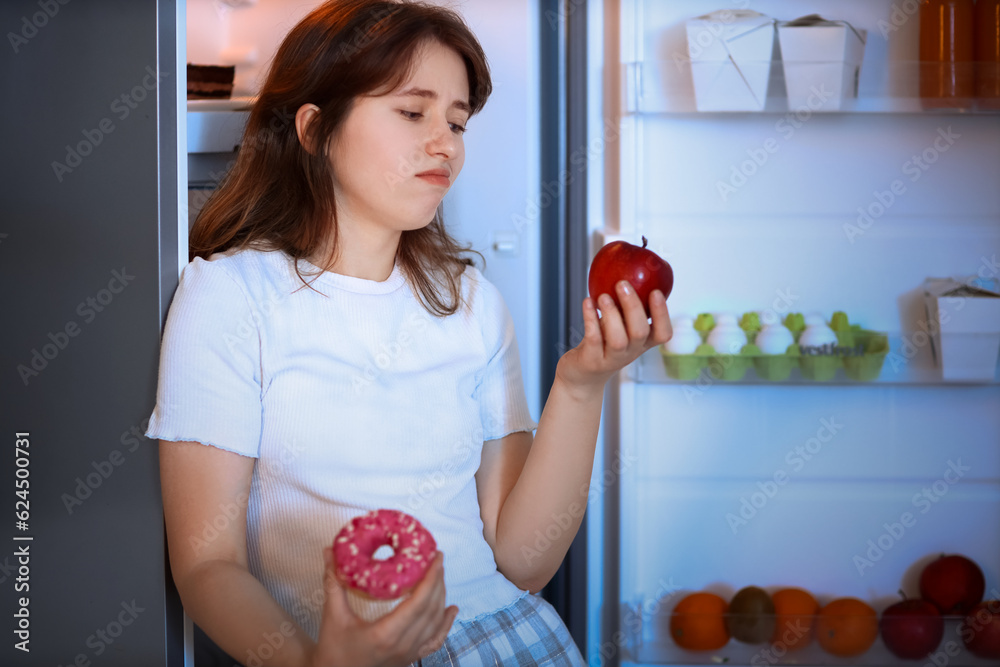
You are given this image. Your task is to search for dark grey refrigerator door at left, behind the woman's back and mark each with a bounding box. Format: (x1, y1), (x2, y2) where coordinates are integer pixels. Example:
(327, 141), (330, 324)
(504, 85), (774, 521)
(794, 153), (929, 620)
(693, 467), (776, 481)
(0, 0), (184, 667)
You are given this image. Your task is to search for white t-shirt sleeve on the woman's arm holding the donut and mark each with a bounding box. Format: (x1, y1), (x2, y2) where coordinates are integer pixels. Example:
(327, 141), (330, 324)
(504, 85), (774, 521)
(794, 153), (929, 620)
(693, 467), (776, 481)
(146, 258), (261, 457)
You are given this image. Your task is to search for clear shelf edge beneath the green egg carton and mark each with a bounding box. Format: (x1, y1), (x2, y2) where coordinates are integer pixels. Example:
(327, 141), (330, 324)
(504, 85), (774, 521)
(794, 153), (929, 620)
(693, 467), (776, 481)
(625, 333), (1000, 390)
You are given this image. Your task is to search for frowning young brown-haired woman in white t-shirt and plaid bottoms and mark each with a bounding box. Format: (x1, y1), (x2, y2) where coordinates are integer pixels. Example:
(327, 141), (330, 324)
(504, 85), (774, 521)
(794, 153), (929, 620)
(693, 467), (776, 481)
(147, 0), (670, 667)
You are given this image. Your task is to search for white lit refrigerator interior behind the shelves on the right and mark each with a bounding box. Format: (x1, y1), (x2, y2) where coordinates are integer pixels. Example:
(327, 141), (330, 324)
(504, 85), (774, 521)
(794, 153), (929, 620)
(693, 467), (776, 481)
(588, 0), (1000, 665)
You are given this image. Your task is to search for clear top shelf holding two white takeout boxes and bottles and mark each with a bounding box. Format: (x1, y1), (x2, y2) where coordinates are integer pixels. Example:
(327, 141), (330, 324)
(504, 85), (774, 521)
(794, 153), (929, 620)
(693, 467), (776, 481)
(622, 58), (1000, 120)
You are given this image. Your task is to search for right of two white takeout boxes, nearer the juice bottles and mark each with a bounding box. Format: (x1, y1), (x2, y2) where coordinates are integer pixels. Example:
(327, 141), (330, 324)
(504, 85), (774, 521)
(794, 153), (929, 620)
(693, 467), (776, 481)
(778, 14), (868, 112)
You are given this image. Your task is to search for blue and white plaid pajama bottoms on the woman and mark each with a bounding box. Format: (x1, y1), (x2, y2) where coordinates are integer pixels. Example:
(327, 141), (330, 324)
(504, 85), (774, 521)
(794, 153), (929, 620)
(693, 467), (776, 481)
(413, 595), (586, 667)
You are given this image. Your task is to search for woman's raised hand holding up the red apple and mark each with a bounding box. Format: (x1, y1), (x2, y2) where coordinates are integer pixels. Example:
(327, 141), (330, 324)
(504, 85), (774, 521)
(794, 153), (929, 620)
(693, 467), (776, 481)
(556, 280), (673, 392)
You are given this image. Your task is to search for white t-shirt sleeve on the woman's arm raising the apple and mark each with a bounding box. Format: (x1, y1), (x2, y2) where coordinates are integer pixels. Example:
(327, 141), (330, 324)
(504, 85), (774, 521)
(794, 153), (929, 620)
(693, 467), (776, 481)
(475, 272), (538, 441)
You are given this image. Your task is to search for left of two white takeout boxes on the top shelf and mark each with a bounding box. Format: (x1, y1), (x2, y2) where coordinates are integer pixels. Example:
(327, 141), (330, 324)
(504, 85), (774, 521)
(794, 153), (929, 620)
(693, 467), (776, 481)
(687, 9), (774, 111)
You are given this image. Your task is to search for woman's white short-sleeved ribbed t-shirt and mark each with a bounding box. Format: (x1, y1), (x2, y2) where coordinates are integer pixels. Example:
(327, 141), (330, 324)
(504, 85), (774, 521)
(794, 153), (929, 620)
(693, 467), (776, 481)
(146, 245), (537, 638)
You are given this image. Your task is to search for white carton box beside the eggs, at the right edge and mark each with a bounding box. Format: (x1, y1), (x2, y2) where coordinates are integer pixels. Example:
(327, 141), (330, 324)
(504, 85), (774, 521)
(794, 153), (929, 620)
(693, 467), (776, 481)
(924, 278), (1000, 382)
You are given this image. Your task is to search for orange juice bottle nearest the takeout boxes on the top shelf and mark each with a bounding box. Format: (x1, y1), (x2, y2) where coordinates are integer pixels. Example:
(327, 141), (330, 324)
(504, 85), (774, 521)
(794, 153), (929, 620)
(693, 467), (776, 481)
(920, 0), (976, 109)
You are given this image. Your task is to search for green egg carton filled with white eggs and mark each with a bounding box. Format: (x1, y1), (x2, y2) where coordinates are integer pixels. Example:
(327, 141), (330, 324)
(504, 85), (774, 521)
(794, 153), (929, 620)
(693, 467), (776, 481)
(660, 311), (889, 382)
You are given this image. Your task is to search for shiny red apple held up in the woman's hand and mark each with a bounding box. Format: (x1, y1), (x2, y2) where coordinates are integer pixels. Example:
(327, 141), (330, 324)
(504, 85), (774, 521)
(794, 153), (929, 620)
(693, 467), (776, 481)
(587, 236), (674, 317)
